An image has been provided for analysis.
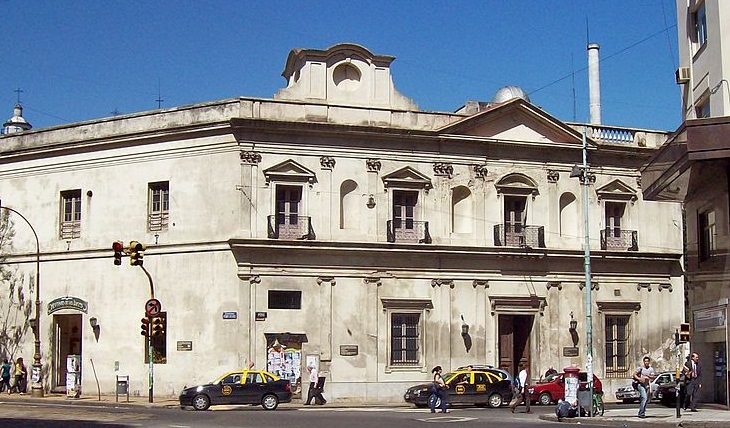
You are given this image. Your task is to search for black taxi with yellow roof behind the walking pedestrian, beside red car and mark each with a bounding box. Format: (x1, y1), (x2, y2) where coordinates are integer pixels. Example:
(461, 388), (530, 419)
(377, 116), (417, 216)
(403, 368), (512, 408)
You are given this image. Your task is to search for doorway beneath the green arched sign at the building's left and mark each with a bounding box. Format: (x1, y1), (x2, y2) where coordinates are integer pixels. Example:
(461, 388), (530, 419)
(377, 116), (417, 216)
(51, 314), (83, 392)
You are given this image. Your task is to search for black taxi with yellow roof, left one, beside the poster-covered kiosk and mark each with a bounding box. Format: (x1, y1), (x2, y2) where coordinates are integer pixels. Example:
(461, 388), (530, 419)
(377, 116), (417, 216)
(180, 370), (291, 410)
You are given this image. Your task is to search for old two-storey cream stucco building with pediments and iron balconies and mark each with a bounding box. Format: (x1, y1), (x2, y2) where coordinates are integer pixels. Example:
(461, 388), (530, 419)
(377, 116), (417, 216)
(0, 44), (684, 401)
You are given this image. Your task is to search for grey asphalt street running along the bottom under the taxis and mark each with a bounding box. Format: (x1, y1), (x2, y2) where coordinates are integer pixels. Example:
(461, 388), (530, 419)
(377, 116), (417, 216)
(0, 402), (676, 428)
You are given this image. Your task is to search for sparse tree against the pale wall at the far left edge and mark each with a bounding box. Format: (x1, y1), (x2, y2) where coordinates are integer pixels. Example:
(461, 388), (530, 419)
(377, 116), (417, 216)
(0, 210), (35, 360)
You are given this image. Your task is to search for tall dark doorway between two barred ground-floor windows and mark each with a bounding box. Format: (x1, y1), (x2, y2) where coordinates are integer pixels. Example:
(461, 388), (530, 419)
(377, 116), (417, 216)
(497, 315), (535, 375)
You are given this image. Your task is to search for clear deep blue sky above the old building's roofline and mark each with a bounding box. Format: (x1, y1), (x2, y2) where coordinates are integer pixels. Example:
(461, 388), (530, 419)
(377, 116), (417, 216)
(0, 0), (681, 130)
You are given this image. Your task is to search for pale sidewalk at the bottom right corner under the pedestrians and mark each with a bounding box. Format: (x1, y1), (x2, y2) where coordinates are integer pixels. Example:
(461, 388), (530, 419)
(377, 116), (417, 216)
(540, 404), (730, 428)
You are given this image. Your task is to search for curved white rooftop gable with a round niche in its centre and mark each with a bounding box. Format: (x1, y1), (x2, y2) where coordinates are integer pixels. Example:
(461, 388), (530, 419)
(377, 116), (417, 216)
(274, 43), (418, 110)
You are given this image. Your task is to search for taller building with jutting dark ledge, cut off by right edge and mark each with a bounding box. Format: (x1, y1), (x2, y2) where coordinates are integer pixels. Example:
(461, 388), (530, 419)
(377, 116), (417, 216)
(642, 0), (730, 405)
